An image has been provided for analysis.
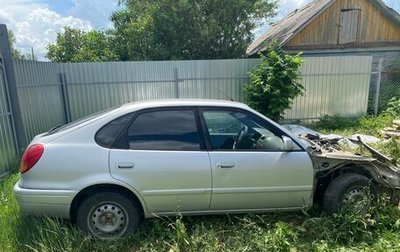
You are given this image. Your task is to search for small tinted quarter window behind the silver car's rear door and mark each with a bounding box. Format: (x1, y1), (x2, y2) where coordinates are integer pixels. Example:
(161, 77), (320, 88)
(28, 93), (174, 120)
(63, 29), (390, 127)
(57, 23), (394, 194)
(95, 113), (133, 148)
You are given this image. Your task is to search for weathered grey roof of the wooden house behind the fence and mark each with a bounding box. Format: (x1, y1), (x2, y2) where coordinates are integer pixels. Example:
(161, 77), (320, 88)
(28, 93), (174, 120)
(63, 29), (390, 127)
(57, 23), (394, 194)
(246, 0), (400, 55)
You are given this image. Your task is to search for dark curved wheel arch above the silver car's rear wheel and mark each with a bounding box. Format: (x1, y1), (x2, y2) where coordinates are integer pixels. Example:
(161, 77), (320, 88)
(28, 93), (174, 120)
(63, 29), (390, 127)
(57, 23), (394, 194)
(69, 183), (145, 223)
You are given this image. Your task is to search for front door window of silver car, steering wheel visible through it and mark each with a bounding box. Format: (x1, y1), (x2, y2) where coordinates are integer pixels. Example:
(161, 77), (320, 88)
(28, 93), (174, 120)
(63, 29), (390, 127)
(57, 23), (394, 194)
(202, 110), (283, 150)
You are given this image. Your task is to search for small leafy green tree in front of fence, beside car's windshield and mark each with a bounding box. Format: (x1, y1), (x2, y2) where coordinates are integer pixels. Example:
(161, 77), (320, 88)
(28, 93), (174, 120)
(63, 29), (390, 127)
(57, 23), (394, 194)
(244, 44), (304, 121)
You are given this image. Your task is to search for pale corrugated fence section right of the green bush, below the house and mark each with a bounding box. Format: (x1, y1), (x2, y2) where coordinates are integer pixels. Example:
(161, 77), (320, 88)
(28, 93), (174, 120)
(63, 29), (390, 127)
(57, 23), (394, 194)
(285, 56), (372, 119)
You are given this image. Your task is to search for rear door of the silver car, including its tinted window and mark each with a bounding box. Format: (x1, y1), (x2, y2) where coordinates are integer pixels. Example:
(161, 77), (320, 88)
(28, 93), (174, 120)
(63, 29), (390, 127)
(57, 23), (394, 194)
(109, 108), (211, 213)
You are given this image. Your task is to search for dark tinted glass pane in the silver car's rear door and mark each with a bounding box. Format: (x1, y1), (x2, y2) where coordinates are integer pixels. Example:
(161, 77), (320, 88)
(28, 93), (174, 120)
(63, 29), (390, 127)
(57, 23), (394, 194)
(120, 110), (200, 150)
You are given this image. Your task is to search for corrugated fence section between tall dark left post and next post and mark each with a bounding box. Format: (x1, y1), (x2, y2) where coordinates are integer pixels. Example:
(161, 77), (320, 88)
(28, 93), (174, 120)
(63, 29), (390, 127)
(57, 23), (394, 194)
(14, 60), (67, 144)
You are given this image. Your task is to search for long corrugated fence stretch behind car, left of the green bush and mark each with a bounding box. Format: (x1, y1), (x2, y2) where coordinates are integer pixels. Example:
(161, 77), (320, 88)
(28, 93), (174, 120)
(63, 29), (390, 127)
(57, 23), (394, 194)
(14, 59), (259, 142)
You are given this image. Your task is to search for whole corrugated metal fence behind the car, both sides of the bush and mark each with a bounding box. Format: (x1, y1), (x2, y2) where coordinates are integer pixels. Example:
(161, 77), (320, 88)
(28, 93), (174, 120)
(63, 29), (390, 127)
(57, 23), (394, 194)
(14, 56), (372, 141)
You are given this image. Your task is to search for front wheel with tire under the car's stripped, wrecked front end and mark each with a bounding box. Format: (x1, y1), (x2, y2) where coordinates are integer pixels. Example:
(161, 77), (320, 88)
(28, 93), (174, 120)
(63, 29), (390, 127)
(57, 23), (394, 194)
(323, 173), (376, 214)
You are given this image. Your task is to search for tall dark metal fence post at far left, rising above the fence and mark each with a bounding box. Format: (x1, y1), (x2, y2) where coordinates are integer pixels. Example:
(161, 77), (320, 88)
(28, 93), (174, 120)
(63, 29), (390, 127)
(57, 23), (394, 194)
(0, 24), (27, 151)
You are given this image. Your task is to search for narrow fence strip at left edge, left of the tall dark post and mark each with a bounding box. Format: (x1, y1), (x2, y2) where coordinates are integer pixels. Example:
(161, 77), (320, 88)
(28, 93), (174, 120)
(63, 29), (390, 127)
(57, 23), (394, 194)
(0, 55), (17, 177)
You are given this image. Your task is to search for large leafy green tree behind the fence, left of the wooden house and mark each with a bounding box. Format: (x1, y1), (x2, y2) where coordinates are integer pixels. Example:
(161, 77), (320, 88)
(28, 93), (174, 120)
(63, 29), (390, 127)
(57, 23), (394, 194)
(111, 0), (276, 60)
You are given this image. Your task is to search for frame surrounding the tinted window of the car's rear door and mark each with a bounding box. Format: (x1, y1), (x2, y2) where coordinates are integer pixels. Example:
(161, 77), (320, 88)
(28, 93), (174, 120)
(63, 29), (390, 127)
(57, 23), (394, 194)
(111, 106), (207, 152)
